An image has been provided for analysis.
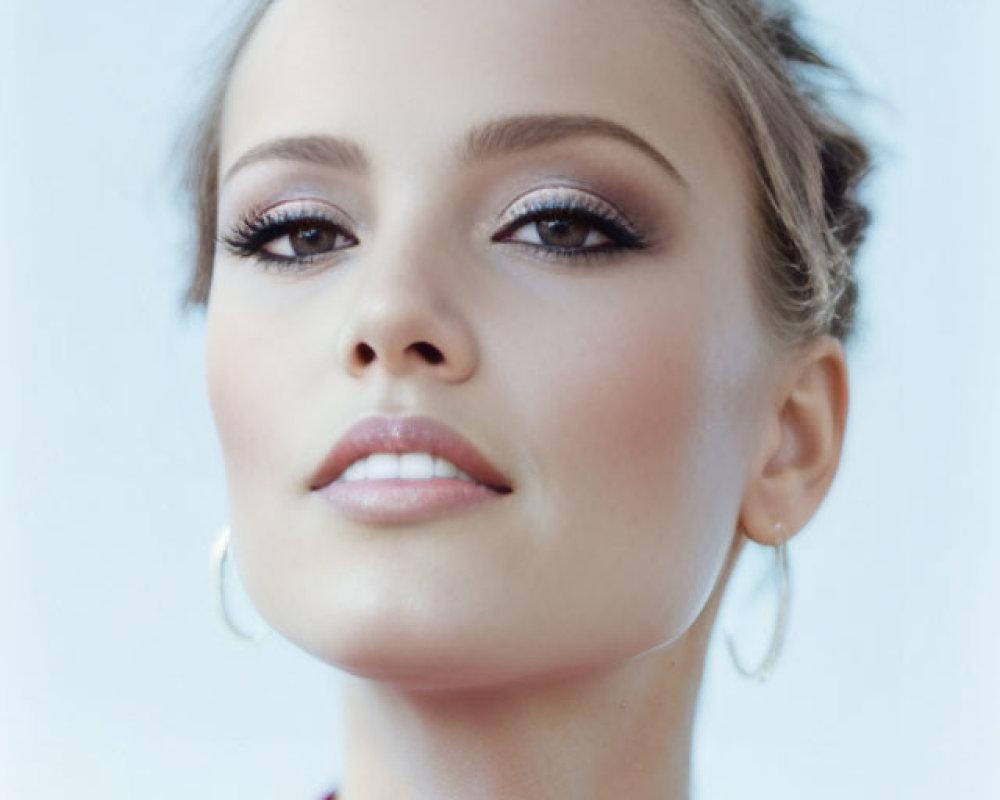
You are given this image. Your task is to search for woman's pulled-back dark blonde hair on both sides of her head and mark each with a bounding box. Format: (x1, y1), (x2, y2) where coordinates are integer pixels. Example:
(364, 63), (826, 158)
(185, 0), (871, 344)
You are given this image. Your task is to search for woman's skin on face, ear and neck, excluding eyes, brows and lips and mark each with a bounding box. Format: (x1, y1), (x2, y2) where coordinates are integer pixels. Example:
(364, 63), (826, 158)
(207, 0), (847, 800)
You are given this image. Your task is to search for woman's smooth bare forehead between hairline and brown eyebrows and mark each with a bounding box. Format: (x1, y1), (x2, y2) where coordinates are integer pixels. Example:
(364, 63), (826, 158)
(222, 0), (731, 183)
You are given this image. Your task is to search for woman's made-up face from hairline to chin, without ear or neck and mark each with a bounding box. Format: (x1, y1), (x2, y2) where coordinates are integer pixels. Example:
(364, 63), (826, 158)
(208, 0), (772, 688)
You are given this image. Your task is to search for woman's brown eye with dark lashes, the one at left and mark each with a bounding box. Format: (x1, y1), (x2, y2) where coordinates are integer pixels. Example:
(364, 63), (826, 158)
(222, 209), (358, 265)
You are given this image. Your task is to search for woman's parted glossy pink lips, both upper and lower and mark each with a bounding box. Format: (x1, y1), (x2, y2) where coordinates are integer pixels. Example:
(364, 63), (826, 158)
(311, 416), (513, 524)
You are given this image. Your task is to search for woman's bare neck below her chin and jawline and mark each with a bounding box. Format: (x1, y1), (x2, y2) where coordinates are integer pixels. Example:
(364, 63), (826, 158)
(338, 597), (718, 800)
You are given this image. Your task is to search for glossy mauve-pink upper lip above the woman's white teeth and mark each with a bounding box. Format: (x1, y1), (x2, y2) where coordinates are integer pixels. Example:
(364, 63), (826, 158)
(311, 416), (511, 492)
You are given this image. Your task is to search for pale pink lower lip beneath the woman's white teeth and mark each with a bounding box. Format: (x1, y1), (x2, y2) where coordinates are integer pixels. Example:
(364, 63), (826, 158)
(317, 478), (505, 525)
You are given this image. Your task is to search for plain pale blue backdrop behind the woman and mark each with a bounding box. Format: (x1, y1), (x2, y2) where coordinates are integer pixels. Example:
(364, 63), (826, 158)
(0, 0), (1000, 800)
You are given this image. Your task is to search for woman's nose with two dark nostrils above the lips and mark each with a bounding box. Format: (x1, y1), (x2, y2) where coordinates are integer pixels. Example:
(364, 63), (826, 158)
(338, 245), (478, 383)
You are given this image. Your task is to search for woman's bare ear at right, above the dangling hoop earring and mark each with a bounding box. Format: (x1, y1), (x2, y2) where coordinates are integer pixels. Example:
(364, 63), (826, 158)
(740, 336), (848, 546)
